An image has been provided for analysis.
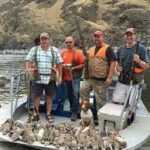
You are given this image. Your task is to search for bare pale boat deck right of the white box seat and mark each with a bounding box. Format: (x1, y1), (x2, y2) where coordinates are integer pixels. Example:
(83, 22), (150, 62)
(120, 101), (150, 150)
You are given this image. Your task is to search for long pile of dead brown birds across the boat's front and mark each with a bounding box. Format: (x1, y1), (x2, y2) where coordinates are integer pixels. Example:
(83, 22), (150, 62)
(0, 120), (126, 150)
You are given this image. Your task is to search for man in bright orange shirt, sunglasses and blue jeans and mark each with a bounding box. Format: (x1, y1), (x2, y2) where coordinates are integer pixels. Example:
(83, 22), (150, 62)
(61, 36), (85, 121)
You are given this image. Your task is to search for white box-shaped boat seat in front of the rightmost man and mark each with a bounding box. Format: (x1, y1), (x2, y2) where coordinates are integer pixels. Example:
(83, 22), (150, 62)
(98, 84), (142, 131)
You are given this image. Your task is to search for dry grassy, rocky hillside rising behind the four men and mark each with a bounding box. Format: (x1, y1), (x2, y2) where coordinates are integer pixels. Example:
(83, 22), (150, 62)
(0, 0), (150, 49)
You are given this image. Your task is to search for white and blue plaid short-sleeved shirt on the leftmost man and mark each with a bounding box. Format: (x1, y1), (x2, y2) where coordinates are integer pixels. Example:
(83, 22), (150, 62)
(25, 46), (63, 84)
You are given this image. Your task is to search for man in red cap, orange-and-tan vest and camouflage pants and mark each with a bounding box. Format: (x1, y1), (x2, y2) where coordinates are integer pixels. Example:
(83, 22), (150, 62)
(80, 31), (116, 123)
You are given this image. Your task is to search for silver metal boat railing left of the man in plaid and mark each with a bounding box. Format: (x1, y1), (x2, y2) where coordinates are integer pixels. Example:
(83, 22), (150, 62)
(10, 71), (27, 119)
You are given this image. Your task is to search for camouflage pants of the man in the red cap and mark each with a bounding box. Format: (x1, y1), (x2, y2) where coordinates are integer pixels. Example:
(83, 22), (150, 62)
(80, 79), (106, 110)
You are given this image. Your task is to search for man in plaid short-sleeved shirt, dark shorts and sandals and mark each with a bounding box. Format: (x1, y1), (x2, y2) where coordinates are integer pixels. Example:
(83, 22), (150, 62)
(25, 32), (63, 122)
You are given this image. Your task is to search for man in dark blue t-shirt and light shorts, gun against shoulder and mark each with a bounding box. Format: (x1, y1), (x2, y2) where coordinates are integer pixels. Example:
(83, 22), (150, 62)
(113, 28), (149, 124)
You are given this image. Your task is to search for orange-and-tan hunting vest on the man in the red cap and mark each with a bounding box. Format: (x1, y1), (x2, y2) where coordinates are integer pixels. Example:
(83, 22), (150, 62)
(88, 44), (109, 78)
